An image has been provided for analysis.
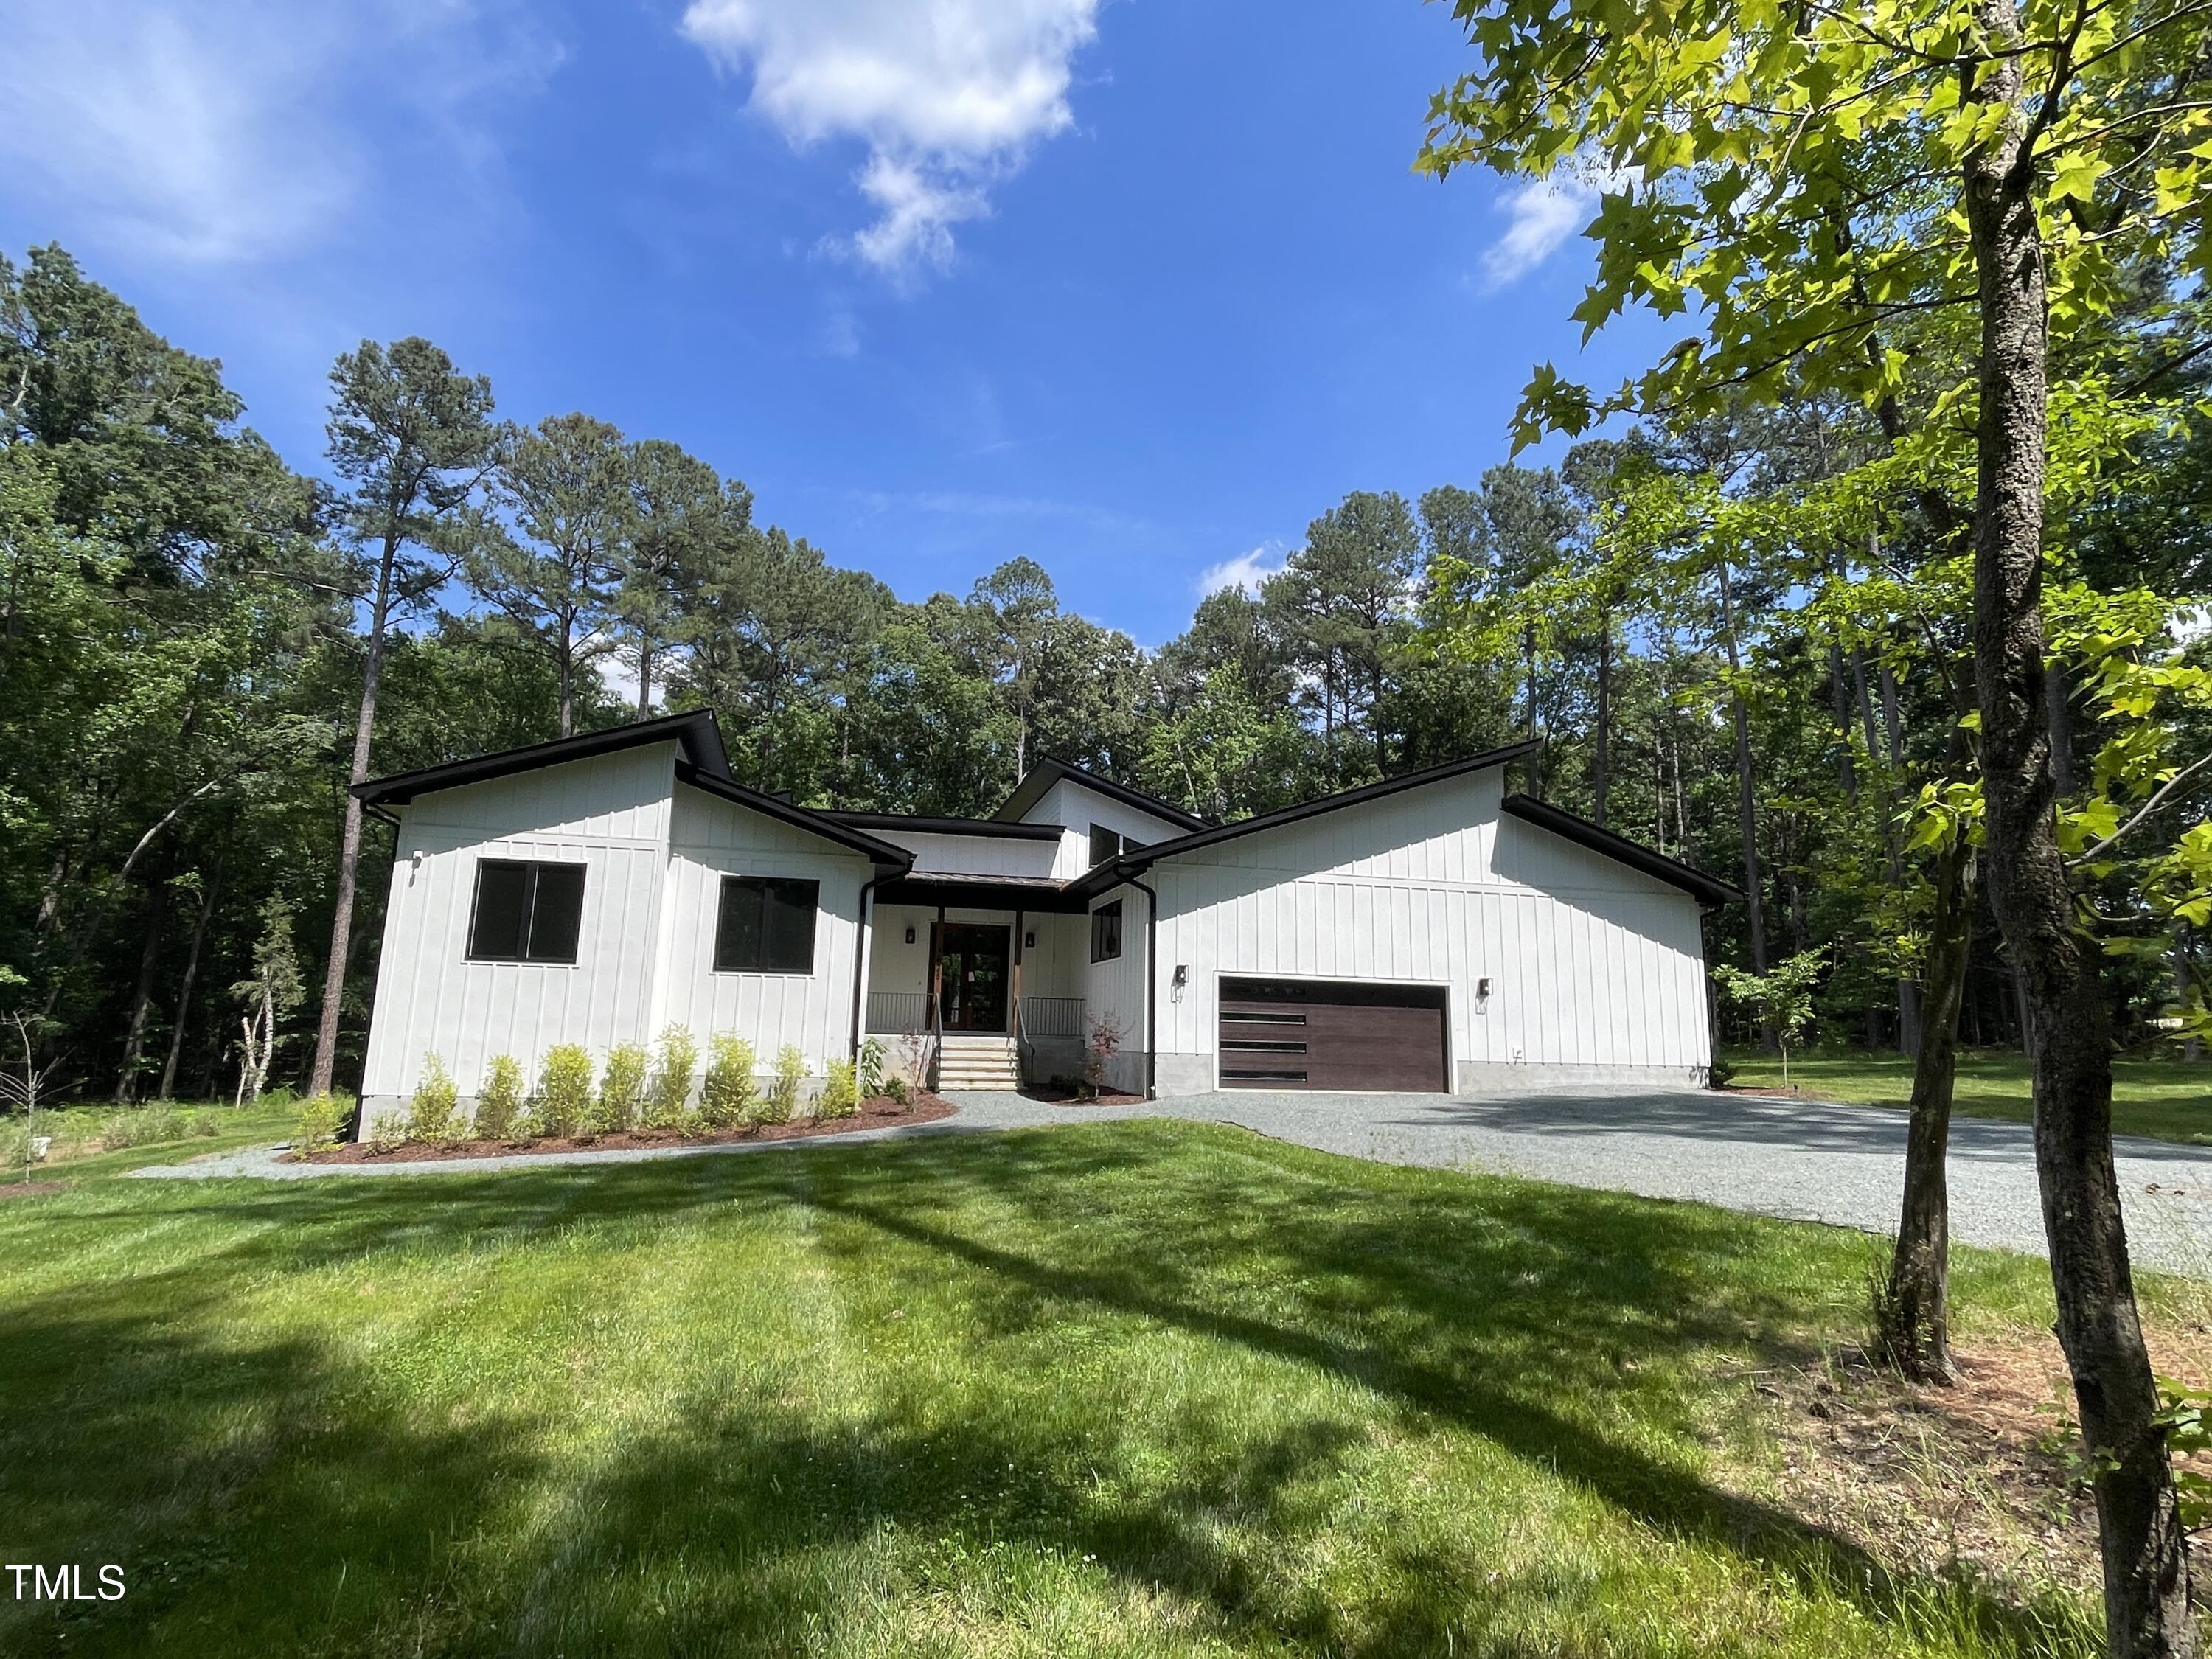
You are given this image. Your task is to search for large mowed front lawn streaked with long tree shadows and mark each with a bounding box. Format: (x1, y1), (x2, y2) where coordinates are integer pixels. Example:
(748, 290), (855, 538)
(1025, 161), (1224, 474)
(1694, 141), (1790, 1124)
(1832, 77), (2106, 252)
(0, 1121), (2157, 1659)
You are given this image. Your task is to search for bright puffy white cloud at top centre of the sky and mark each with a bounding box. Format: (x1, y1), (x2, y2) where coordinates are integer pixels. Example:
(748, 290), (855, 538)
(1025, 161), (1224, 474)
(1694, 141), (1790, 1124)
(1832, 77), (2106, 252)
(684, 0), (1097, 274)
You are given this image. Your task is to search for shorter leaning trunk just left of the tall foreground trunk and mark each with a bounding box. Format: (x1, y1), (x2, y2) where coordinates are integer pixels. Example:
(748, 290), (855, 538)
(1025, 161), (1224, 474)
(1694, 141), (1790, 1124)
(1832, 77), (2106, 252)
(1880, 834), (1975, 1382)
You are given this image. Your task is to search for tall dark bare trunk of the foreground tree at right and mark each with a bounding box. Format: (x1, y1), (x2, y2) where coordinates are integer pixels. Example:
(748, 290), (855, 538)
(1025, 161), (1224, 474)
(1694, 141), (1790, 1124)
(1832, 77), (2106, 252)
(1964, 19), (2199, 1659)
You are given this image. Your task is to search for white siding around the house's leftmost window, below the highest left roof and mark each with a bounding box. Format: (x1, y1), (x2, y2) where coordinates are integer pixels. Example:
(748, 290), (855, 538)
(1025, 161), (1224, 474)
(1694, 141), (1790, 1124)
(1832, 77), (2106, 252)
(361, 743), (677, 1102)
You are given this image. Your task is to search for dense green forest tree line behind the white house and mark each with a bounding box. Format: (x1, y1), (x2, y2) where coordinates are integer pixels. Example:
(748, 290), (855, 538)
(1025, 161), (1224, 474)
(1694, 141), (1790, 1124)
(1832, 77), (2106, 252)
(0, 248), (2212, 1099)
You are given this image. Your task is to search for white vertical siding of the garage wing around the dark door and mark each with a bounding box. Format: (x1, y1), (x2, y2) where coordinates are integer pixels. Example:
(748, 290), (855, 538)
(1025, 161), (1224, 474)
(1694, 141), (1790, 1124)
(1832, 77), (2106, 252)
(1139, 770), (1712, 1093)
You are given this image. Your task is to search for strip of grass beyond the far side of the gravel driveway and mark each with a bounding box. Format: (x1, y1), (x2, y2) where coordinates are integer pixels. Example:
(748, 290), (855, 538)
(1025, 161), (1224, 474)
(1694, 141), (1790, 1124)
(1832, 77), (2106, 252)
(1728, 1051), (2212, 1146)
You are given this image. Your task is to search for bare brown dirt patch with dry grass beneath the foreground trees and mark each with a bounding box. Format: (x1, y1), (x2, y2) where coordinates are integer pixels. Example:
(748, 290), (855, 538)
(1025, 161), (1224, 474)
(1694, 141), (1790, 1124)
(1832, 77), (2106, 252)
(1745, 1327), (2212, 1597)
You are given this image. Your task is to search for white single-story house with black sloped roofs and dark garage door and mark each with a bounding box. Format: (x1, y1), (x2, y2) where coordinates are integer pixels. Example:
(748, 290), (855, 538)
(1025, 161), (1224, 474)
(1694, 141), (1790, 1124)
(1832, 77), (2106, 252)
(356, 714), (1739, 1121)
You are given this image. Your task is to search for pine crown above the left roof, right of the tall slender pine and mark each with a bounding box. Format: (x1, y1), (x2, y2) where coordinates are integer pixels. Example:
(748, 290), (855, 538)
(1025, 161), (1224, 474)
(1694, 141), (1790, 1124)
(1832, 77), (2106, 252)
(467, 414), (633, 737)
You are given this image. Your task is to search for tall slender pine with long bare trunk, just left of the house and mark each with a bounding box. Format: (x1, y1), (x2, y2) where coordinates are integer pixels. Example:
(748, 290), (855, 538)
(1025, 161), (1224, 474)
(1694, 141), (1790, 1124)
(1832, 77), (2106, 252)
(307, 338), (498, 1095)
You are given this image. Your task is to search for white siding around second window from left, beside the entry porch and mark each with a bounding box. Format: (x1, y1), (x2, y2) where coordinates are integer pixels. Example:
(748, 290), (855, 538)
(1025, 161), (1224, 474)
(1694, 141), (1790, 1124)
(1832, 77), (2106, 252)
(653, 783), (874, 1077)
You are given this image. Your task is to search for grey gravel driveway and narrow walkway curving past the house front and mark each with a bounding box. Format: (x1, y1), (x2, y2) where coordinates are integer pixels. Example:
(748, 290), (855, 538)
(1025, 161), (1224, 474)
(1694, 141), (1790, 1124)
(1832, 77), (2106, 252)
(137, 1091), (2212, 1279)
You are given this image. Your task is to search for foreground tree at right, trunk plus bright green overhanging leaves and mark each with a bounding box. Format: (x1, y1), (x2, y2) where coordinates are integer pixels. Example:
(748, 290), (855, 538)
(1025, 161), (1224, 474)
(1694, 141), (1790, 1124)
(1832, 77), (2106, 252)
(1425, 0), (2212, 1657)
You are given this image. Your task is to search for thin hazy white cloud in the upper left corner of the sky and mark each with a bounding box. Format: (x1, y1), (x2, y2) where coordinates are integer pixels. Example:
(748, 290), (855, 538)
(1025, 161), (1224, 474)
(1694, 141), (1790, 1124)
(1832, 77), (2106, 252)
(0, 0), (557, 263)
